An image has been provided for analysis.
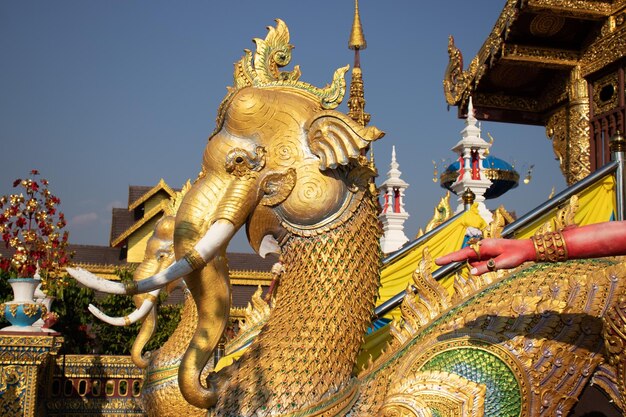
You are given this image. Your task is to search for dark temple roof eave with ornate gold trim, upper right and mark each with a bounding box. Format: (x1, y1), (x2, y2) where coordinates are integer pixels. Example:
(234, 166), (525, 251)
(444, 0), (626, 124)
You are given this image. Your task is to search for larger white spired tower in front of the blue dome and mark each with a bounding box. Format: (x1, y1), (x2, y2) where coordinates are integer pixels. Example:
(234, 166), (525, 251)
(450, 97), (493, 223)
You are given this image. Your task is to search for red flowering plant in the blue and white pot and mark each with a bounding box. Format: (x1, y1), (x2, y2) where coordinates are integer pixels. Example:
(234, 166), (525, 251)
(0, 170), (73, 287)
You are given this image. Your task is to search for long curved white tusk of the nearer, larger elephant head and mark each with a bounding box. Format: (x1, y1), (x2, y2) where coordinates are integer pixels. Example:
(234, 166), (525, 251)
(67, 220), (236, 295)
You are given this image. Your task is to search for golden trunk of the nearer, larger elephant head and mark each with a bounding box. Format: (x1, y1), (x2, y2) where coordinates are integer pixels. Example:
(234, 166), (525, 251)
(174, 168), (259, 409)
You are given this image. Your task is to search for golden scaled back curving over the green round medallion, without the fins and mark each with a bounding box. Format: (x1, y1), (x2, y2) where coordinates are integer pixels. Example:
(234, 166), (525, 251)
(353, 255), (626, 416)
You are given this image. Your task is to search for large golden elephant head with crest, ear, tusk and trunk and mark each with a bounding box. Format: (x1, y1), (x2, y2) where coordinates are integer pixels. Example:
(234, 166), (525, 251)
(70, 20), (383, 408)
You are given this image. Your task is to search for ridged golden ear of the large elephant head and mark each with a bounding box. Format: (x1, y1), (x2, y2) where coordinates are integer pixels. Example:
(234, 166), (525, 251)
(307, 110), (385, 170)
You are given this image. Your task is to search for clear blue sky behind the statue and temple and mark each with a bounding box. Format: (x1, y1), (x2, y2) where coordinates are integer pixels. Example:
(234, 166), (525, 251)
(0, 0), (565, 251)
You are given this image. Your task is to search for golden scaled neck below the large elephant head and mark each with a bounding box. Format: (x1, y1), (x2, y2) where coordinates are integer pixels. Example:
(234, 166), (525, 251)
(214, 196), (380, 416)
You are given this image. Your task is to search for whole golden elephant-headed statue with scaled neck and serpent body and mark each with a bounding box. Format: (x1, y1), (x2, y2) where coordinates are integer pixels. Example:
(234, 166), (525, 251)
(70, 20), (626, 417)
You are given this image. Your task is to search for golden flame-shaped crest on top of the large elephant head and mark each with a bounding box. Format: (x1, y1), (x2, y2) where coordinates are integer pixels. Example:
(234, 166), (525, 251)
(215, 19), (350, 132)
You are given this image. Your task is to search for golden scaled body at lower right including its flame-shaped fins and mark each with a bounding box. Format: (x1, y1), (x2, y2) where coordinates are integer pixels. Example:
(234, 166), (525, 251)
(351, 196), (626, 417)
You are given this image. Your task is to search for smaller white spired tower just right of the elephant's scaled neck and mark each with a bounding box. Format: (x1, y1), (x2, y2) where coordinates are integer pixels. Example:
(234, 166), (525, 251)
(379, 146), (409, 254)
